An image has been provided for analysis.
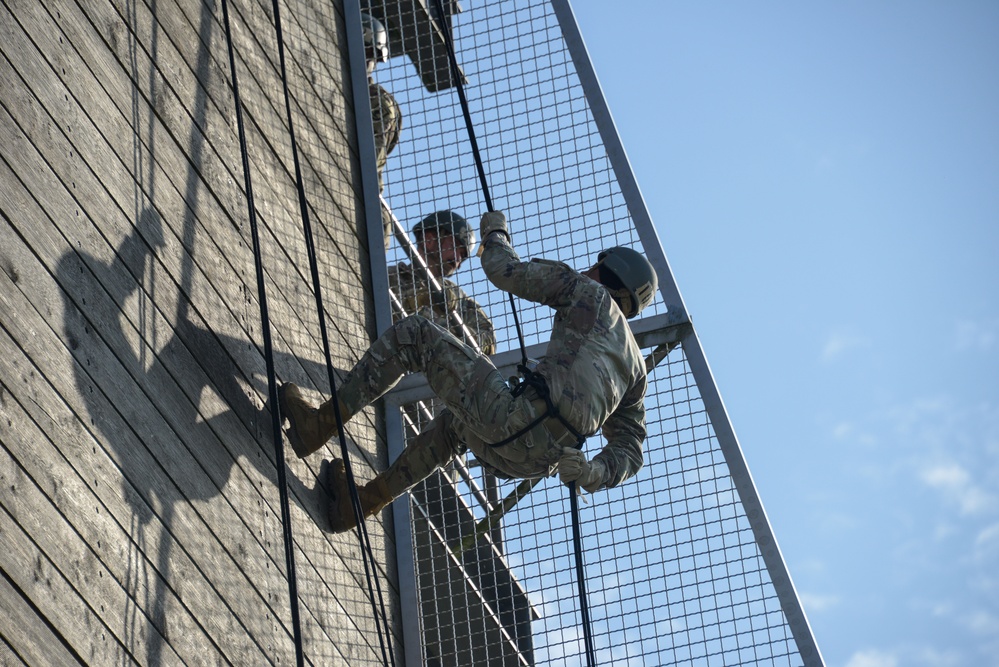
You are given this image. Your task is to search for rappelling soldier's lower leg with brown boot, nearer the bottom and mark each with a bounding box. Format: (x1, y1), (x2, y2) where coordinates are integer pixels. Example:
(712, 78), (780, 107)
(328, 410), (465, 532)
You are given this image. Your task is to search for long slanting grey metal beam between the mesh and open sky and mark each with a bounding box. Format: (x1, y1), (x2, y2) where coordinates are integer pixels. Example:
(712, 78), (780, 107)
(551, 0), (825, 667)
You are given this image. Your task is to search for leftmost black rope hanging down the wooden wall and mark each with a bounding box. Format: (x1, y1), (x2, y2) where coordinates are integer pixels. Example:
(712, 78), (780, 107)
(222, 0), (305, 667)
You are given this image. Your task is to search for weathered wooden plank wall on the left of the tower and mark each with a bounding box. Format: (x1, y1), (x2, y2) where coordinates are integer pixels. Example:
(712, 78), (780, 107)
(0, 0), (401, 665)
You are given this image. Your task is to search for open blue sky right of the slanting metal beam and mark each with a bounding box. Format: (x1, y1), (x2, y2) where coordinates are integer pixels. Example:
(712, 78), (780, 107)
(573, 0), (999, 667)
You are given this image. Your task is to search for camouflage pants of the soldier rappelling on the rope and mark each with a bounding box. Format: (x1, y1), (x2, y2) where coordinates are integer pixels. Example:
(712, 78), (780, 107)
(338, 315), (561, 493)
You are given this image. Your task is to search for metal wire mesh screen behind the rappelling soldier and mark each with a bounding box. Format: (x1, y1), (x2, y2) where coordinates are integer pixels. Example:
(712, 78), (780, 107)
(362, 0), (803, 665)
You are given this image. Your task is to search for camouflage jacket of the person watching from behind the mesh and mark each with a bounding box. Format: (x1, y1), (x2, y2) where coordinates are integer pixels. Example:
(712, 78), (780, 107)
(389, 263), (496, 354)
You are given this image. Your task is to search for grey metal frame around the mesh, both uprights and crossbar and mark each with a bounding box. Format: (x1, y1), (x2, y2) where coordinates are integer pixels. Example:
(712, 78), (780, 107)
(352, 0), (825, 667)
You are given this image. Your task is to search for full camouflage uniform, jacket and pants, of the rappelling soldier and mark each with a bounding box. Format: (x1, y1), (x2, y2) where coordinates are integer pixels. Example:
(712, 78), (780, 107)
(339, 234), (646, 496)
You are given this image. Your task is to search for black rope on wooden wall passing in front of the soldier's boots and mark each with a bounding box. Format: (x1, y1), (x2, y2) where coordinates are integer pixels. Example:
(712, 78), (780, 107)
(273, 0), (395, 665)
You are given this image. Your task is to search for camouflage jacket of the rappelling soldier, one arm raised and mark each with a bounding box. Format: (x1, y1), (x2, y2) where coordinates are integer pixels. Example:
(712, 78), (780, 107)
(482, 234), (646, 486)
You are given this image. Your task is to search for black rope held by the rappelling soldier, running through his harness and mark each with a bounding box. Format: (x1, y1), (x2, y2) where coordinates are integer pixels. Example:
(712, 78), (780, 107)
(434, 0), (596, 667)
